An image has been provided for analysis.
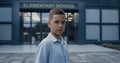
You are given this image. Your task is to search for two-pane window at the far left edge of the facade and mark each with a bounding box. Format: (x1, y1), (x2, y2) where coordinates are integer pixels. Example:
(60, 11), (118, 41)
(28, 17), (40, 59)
(0, 7), (12, 40)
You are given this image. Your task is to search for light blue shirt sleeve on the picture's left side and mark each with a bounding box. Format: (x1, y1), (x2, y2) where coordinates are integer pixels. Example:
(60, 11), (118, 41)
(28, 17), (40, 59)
(35, 43), (49, 63)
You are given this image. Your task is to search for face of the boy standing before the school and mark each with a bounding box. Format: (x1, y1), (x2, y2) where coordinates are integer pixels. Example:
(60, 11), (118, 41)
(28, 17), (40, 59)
(48, 15), (66, 36)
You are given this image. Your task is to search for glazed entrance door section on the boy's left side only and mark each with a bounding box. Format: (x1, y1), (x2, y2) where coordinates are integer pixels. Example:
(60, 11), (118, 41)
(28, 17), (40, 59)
(21, 12), (49, 45)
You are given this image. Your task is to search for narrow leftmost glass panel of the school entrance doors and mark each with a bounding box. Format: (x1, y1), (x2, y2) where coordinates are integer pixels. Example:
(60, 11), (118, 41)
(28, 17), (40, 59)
(22, 12), (31, 44)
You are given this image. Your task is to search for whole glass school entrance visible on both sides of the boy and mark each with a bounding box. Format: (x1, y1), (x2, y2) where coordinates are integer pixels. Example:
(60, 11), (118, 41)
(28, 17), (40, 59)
(21, 12), (79, 45)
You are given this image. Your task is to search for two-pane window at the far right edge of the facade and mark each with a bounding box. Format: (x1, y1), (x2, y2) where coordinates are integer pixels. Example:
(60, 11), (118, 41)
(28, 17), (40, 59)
(102, 9), (119, 40)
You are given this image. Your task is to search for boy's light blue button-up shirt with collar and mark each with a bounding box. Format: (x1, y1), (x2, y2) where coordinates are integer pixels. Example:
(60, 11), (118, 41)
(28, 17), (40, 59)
(35, 33), (69, 63)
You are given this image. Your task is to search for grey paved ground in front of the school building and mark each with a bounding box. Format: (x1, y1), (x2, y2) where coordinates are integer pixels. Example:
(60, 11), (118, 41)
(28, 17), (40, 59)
(0, 45), (120, 63)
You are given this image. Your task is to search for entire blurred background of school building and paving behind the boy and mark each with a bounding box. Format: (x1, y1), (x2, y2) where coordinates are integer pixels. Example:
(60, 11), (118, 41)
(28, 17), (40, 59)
(0, 0), (120, 63)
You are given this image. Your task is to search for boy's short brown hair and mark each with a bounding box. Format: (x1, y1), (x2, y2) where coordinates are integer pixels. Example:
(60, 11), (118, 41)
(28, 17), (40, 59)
(49, 8), (65, 20)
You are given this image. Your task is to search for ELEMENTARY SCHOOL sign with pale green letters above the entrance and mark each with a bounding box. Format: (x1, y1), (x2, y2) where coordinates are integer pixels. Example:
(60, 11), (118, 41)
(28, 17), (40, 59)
(20, 2), (78, 9)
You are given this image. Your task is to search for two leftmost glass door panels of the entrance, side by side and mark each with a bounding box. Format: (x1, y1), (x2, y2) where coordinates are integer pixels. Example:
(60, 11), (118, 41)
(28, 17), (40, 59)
(22, 12), (41, 44)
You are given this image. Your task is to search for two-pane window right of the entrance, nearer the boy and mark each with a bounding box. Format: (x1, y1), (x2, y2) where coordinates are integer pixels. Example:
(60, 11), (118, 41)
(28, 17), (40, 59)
(86, 9), (100, 41)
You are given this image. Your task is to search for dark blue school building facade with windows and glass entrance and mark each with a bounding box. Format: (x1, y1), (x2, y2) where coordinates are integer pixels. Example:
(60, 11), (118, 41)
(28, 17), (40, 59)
(0, 0), (120, 45)
